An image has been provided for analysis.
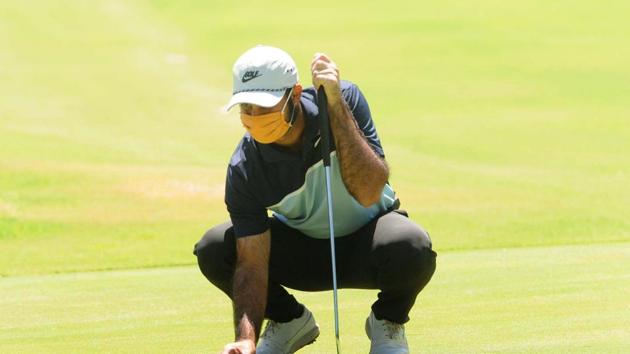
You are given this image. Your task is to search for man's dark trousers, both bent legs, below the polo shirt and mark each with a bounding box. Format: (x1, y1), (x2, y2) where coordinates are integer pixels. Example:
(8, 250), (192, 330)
(195, 211), (436, 324)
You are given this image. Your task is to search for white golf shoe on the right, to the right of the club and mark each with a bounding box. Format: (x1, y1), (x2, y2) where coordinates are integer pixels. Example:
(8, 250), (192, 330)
(365, 312), (409, 354)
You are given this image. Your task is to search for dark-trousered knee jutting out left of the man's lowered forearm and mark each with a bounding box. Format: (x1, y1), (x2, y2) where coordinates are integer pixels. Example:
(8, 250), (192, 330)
(193, 222), (235, 283)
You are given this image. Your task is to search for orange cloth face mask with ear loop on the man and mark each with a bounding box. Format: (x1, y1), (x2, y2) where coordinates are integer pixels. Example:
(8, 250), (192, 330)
(241, 93), (295, 144)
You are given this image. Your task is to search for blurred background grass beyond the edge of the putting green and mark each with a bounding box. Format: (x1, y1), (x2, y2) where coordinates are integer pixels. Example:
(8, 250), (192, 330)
(0, 0), (630, 276)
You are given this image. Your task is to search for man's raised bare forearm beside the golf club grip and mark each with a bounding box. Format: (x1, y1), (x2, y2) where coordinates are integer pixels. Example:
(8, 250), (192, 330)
(328, 97), (389, 207)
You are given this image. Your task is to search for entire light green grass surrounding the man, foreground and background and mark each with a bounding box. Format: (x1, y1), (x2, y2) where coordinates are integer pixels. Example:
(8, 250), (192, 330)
(0, 0), (630, 353)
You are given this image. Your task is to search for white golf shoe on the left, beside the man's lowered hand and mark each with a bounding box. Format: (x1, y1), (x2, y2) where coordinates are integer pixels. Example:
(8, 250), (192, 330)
(256, 307), (319, 354)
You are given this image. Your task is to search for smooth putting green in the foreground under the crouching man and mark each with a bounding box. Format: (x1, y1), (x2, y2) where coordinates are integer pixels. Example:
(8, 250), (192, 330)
(0, 243), (630, 353)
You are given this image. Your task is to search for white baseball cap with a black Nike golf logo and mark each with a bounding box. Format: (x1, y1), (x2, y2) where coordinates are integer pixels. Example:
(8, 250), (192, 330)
(225, 45), (298, 111)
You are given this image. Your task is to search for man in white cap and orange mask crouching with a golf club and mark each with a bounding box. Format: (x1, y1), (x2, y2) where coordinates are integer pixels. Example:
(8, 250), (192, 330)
(194, 46), (436, 354)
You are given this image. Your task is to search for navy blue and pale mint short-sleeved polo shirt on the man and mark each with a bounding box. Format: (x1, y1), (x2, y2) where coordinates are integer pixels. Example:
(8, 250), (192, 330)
(225, 81), (396, 238)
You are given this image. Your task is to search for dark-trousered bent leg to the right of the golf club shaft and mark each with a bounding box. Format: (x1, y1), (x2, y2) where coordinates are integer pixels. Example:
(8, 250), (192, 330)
(337, 211), (436, 324)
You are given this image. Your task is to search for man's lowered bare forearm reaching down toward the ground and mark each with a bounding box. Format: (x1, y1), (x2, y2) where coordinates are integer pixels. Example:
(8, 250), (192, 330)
(232, 265), (268, 343)
